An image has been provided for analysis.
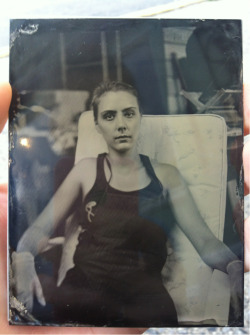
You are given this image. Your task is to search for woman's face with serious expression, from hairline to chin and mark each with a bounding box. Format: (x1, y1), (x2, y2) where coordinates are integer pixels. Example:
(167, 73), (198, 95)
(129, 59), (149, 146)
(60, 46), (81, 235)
(96, 91), (141, 152)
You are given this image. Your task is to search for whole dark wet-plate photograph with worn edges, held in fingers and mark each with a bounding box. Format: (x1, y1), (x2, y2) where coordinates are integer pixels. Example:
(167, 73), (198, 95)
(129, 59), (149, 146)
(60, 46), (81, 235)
(8, 19), (244, 327)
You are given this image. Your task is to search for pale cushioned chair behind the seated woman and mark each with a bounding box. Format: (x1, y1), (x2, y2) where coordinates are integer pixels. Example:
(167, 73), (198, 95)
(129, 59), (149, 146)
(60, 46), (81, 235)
(50, 111), (230, 325)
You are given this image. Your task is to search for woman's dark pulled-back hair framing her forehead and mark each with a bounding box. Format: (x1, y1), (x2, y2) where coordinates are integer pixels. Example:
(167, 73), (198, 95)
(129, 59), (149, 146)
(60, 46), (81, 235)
(91, 81), (141, 123)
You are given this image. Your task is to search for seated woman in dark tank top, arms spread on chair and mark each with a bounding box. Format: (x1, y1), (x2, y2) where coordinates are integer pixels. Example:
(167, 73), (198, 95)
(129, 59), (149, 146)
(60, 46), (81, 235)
(13, 82), (242, 327)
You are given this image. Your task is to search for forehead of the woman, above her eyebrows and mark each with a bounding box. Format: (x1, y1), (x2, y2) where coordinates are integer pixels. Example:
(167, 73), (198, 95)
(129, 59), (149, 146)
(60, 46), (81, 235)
(99, 91), (138, 109)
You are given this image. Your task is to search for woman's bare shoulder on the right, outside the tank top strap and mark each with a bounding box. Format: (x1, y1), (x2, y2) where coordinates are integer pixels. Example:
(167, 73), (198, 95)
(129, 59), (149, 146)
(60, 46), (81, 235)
(152, 161), (183, 189)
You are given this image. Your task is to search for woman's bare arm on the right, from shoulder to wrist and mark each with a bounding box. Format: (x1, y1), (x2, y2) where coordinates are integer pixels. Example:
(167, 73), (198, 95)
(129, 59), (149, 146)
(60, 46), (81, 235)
(155, 165), (237, 272)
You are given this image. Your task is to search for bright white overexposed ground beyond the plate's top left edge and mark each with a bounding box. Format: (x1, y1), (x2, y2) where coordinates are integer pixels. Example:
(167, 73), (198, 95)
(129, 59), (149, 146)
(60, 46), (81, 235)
(0, 0), (176, 48)
